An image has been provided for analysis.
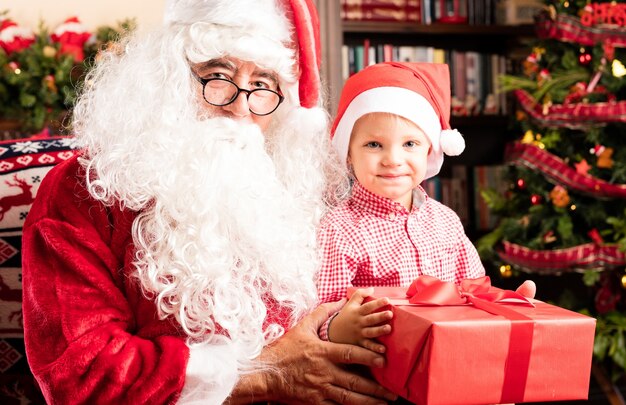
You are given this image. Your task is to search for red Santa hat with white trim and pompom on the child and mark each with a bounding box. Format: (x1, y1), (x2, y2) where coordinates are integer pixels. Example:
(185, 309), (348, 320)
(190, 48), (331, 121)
(331, 62), (465, 178)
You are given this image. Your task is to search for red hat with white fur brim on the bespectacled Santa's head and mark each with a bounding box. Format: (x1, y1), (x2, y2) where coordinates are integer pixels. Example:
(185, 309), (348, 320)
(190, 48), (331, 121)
(165, 0), (321, 108)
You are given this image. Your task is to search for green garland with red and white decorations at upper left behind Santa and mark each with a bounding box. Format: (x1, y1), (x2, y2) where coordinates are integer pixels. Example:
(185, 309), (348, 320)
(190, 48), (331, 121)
(0, 11), (135, 136)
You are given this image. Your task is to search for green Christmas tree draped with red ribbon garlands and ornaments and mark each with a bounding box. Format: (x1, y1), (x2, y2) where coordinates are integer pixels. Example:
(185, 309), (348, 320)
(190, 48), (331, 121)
(478, 0), (626, 379)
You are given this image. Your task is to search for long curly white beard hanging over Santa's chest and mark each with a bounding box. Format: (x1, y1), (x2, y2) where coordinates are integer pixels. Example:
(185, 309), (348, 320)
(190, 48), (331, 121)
(116, 118), (317, 358)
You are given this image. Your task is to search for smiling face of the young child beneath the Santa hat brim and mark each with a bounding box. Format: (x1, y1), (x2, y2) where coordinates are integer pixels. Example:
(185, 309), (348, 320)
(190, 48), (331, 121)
(348, 113), (430, 209)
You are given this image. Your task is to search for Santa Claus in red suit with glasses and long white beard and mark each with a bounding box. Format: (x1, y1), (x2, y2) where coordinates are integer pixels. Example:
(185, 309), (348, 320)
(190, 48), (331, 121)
(23, 0), (395, 404)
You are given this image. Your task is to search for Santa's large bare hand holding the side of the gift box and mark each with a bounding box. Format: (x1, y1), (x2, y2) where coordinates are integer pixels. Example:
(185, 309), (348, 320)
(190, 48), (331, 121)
(261, 300), (397, 405)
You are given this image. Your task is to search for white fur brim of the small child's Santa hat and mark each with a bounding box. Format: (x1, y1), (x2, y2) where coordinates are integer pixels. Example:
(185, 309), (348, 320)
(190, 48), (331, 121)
(332, 87), (444, 178)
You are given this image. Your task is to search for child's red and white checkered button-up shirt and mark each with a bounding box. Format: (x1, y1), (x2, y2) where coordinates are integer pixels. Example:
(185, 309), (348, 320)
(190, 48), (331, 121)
(317, 182), (485, 302)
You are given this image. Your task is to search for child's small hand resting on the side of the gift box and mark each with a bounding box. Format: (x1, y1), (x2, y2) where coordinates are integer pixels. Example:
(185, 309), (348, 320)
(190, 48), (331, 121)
(328, 288), (393, 353)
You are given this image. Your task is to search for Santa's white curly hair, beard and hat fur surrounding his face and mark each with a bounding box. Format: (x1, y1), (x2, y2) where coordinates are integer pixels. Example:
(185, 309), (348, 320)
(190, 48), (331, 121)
(73, 0), (343, 374)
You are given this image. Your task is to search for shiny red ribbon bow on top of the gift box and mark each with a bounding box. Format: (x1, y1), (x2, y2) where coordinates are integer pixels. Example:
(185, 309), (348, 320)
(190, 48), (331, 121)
(406, 275), (534, 306)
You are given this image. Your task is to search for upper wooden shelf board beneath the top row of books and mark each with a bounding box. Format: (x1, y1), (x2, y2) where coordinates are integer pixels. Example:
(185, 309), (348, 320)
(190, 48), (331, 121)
(342, 21), (535, 37)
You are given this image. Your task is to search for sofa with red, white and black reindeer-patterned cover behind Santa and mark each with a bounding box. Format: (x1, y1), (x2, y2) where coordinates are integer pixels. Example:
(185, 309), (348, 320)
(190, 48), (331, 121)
(0, 133), (78, 405)
